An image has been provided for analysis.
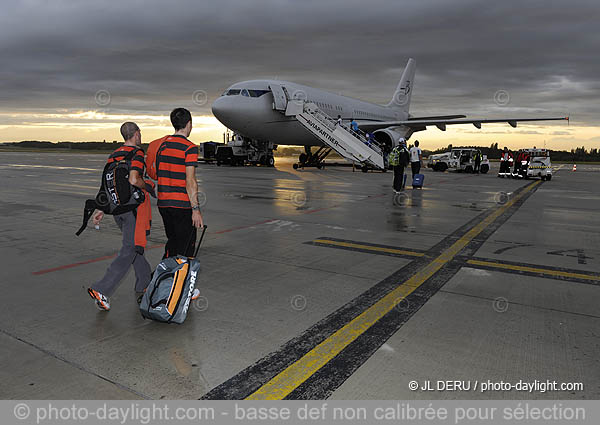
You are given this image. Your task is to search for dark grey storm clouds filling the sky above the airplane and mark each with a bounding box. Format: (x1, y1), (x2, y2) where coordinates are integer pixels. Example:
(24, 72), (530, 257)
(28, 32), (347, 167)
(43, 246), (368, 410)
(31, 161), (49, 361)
(0, 0), (600, 125)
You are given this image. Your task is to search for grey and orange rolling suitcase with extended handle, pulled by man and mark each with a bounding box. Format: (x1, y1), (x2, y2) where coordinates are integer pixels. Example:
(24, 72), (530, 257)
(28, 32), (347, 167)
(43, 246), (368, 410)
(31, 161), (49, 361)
(140, 226), (206, 324)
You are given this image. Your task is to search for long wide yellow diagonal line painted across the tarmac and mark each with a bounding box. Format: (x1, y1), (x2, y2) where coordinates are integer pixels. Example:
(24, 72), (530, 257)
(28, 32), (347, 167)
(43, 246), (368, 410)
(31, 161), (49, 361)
(246, 180), (541, 400)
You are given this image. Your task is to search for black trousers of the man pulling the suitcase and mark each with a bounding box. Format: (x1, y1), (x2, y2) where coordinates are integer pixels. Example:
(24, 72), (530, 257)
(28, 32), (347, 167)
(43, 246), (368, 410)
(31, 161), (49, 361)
(158, 208), (196, 258)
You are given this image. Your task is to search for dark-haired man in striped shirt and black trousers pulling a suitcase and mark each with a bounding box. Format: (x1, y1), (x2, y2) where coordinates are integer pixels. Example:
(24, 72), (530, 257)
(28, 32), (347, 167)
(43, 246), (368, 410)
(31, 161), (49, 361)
(155, 108), (204, 258)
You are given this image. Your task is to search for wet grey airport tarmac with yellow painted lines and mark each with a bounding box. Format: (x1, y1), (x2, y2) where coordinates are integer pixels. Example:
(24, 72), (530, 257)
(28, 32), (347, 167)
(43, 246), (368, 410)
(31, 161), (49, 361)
(0, 152), (600, 399)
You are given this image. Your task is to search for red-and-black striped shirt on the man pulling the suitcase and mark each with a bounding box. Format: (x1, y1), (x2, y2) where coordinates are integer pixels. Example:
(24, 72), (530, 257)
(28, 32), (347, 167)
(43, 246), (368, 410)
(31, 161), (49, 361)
(156, 135), (198, 208)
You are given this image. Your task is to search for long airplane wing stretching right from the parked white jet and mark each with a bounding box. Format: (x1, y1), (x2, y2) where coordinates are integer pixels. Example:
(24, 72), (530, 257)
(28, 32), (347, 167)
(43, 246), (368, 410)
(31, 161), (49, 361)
(357, 115), (569, 131)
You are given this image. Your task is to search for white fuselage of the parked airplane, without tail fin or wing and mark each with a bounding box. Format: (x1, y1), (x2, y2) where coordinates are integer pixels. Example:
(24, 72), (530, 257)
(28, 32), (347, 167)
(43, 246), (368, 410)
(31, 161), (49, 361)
(212, 80), (407, 146)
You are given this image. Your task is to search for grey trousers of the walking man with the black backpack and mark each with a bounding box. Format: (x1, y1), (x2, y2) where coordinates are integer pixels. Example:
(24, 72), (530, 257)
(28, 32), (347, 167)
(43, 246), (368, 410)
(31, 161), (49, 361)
(92, 212), (151, 297)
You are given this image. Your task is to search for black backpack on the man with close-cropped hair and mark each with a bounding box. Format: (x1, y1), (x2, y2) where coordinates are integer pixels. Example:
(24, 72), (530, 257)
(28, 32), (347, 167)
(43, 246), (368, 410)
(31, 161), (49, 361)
(75, 148), (145, 236)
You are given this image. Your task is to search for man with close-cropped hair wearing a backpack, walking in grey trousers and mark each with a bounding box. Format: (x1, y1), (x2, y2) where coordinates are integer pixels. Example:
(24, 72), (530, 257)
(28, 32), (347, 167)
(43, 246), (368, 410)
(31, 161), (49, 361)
(88, 122), (154, 311)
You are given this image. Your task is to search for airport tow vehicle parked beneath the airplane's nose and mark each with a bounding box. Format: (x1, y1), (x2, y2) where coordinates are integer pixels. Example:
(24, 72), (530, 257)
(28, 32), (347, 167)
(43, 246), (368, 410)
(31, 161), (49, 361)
(215, 133), (277, 167)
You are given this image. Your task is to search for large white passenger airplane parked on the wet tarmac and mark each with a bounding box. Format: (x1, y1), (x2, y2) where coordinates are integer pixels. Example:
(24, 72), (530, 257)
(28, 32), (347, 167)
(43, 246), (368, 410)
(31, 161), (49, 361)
(212, 58), (569, 168)
